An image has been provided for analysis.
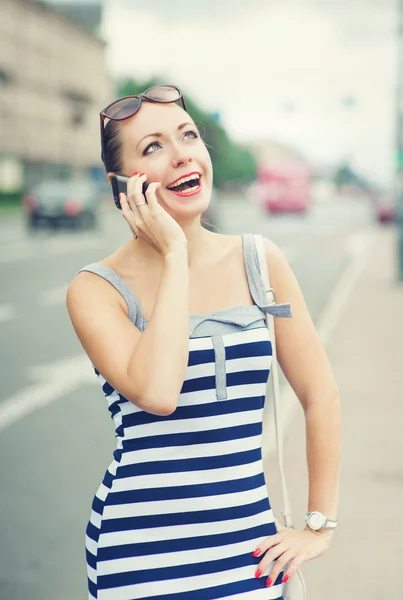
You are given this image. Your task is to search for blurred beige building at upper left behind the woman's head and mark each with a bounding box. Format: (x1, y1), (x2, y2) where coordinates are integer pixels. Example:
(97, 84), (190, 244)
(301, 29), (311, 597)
(0, 0), (113, 193)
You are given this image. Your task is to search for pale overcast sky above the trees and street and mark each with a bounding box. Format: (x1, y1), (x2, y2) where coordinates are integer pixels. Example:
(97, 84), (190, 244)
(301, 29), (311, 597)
(58, 0), (396, 182)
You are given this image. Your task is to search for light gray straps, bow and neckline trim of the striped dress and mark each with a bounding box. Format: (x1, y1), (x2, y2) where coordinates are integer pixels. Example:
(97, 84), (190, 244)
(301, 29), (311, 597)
(79, 233), (292, 400)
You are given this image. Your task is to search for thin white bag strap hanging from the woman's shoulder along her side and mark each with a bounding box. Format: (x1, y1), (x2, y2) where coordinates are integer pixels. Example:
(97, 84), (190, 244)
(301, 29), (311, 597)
(254, 235), (293, 527)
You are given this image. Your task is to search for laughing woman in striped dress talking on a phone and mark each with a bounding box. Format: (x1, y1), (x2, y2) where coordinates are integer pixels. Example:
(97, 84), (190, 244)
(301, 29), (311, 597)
(67, 86), (340, 600)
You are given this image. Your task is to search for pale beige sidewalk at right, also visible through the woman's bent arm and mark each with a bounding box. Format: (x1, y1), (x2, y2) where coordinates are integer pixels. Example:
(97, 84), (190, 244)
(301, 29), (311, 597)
(268, 228), (403, 600)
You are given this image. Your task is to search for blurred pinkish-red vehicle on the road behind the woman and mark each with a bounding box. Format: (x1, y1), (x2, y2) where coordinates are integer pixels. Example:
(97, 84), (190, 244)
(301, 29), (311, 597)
(258, 164), (311, 213)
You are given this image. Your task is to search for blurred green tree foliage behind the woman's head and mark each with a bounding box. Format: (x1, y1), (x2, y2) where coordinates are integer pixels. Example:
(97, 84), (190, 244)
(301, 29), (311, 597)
(117, 77), (256, 187)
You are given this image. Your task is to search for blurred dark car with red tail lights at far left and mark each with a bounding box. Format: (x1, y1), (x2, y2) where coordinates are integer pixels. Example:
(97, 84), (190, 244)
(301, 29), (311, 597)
(22, 179), (99, 229)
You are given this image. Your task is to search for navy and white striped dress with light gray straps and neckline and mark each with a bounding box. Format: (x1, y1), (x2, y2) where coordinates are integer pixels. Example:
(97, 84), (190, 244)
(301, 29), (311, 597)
(82, 234), (291, 600)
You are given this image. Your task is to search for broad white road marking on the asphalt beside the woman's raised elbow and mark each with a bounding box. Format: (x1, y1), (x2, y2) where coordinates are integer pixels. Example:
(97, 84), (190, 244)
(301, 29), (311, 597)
(0, 354), (98, 431)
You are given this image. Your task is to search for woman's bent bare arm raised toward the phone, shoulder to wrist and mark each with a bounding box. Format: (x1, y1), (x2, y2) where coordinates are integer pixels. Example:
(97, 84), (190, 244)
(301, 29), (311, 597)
(67, 247), (189, 415)
